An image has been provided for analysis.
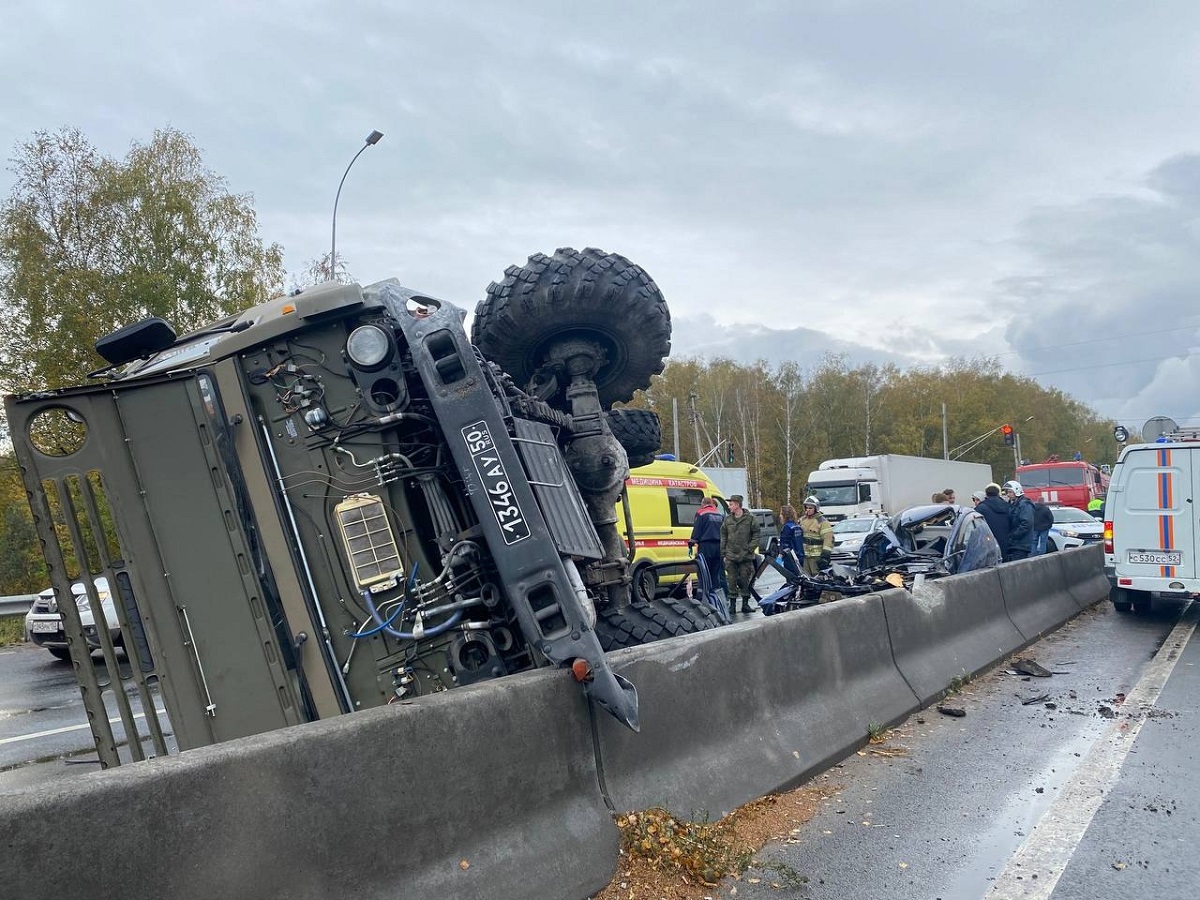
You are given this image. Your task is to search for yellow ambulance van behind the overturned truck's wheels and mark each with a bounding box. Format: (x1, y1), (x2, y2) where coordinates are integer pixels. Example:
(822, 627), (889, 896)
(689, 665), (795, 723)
(617, 460), (730, 595)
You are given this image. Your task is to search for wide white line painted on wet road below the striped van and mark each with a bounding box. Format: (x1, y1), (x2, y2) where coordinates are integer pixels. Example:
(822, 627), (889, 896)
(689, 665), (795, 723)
(984, 601), (1200, 900)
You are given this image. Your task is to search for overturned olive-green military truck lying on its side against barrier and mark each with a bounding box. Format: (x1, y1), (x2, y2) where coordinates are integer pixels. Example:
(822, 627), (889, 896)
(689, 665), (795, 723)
(6, 248), (716, 766)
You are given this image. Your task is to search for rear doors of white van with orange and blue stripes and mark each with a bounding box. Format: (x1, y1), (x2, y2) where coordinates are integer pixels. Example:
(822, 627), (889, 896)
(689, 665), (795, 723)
(1112, 444), (1196, 578)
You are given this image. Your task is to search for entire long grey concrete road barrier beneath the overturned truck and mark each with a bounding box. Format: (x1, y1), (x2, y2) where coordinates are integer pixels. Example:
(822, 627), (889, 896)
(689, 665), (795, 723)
(0, 546), (1109, 900)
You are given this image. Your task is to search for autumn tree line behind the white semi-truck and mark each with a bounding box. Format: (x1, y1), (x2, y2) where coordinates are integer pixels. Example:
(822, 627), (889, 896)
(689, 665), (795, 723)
(634, 354), (1118, 518)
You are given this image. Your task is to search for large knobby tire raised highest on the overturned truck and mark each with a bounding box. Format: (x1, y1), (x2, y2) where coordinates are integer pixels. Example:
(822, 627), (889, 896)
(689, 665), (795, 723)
(470, 247), (671, 409)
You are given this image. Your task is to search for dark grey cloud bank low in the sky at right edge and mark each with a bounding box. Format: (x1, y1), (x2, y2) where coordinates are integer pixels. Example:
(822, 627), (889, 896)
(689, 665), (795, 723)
(997, 155), (1200, 426)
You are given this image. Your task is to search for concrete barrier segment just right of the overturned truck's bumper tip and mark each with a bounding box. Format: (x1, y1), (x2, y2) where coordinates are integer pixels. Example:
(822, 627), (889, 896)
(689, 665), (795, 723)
(596, 594), (918, 821)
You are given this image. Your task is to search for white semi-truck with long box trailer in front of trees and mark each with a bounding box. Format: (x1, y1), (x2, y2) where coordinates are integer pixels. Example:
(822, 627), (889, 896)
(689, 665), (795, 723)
(806, 454), (992, 522)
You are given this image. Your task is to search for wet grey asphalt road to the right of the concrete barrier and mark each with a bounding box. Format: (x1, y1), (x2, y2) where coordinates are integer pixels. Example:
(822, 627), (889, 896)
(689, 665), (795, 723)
(724, 601), (1200, 900)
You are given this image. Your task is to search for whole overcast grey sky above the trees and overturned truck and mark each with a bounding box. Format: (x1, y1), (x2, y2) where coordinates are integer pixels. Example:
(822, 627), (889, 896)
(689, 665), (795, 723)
(0, 0), (1200, 436)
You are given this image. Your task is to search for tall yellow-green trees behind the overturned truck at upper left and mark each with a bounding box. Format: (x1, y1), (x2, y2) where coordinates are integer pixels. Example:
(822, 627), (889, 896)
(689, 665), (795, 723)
(0, 128), (283, 391)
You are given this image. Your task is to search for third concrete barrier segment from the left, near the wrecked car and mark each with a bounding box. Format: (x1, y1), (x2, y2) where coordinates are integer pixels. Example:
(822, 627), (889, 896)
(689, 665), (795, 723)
(883, 569), (1026, 706)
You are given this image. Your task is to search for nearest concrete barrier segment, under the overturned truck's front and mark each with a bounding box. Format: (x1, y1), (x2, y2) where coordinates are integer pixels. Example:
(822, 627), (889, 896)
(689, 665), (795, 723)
(0, 671), (619, 900)
